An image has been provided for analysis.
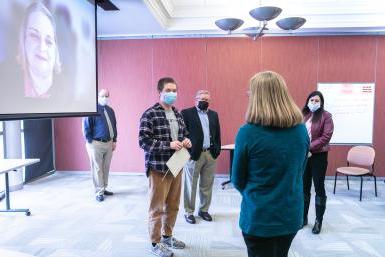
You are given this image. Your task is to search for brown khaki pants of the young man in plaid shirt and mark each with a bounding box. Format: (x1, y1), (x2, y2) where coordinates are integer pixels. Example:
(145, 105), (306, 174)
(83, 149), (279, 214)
(148, 171), (182, 243)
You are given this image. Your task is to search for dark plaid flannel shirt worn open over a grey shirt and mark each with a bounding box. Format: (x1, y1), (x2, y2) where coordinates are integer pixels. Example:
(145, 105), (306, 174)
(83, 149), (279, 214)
(139, 103), (187, 176)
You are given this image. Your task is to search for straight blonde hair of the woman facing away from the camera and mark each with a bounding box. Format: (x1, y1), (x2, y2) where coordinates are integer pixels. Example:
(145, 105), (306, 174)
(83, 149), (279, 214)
(246, 71), (303, 128)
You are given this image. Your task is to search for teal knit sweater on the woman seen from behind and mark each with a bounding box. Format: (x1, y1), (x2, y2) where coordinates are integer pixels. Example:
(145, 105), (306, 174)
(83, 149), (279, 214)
(231, 124), (309, 237)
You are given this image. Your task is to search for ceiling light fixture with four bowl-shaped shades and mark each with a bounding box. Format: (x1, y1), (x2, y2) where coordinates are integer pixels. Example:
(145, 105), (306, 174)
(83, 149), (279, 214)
(215, 6), (306, 40)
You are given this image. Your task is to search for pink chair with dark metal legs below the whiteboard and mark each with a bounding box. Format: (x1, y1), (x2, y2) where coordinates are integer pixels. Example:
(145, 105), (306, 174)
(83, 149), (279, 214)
(333, 146), (377, 201)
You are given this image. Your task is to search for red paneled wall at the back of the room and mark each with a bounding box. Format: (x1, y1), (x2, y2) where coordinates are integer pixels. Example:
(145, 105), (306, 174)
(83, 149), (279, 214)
(55, 36), (385, 176)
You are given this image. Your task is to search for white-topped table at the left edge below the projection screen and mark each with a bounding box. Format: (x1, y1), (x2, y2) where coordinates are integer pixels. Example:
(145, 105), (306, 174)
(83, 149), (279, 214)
(0, 159), (40, 216)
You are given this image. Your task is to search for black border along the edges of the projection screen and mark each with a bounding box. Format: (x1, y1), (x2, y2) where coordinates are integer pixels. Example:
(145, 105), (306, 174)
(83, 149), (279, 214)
(0, 0), (99, 121)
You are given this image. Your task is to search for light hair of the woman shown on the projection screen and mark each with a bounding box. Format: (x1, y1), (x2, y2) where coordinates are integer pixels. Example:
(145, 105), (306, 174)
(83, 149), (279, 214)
(17, 2), (61, 74)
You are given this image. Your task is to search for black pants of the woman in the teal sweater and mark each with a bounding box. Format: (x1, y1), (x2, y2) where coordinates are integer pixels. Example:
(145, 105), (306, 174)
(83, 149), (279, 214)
(242, 230), (297, 257)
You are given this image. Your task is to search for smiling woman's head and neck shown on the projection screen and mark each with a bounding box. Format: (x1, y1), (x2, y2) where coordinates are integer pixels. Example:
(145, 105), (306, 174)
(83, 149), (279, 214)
(18, 2), (61, 98)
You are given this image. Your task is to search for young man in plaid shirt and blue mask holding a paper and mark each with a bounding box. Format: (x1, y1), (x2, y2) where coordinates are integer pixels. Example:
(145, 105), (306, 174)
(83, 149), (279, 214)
(139, 78), (191, 257)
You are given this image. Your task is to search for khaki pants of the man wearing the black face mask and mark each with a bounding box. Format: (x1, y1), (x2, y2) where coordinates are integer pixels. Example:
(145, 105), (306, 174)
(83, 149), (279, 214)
(184, 151), (217, 214)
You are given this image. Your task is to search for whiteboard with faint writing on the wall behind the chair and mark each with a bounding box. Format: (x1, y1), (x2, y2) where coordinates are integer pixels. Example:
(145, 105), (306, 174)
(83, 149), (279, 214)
(318, 83), (375, 145)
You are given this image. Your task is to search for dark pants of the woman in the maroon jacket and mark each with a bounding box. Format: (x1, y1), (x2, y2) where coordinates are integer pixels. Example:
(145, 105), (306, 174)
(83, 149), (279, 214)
(303, 152), (328, 198)
